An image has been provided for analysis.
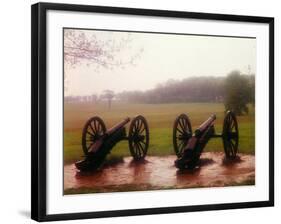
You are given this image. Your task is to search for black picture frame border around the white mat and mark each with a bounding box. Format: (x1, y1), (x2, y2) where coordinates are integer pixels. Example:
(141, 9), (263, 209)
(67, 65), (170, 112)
(31, 3), (274, 221)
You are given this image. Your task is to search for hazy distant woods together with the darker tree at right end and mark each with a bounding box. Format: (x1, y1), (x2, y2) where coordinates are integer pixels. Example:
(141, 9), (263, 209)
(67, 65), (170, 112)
(116, 71), (255, 114)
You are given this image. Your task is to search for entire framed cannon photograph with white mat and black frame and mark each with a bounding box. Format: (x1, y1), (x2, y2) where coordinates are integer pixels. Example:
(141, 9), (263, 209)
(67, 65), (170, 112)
(31, 3), (274, 221)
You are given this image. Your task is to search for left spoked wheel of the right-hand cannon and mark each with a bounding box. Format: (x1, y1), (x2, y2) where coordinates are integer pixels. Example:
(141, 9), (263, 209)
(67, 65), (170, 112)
(173, 114), (192, 157)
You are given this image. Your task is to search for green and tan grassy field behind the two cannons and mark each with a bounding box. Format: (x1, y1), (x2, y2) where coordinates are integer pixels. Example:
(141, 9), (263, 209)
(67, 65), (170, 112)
(64, 102), (255, 164)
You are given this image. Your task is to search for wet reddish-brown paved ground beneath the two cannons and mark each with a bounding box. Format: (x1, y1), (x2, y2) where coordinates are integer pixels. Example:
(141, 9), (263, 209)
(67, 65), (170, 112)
(64, 152), (255, 194)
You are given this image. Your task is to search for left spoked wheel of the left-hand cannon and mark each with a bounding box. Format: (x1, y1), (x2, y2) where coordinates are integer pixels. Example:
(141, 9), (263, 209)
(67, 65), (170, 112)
(82, 117), (106, 155)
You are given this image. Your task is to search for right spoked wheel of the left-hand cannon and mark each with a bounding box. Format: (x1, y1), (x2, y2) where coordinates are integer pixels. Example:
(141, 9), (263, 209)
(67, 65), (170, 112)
(128, 115), (149, 160)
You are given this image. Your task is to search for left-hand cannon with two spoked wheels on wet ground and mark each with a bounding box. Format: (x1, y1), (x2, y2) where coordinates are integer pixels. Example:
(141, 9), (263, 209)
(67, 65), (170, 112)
(75, 115), (149, 171)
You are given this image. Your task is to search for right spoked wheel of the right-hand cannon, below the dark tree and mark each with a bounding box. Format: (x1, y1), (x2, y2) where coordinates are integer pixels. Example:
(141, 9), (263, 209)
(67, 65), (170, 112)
(222, 111), (239, 159)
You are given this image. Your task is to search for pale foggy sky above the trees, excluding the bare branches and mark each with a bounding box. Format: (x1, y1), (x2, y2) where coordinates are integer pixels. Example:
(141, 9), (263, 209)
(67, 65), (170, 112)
(65, 28), (256, 95)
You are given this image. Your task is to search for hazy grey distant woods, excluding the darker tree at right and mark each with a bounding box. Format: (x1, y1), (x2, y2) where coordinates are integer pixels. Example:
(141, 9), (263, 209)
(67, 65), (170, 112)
(117, 77), (224, 103)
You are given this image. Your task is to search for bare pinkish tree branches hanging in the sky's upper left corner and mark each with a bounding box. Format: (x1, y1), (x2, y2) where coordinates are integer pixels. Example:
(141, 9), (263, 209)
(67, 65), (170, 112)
(64, 29), (143, 91)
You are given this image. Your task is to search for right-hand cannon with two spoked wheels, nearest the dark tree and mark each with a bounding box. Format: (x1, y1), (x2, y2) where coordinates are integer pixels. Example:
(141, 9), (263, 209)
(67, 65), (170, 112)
(173, 111), (239, 169)
